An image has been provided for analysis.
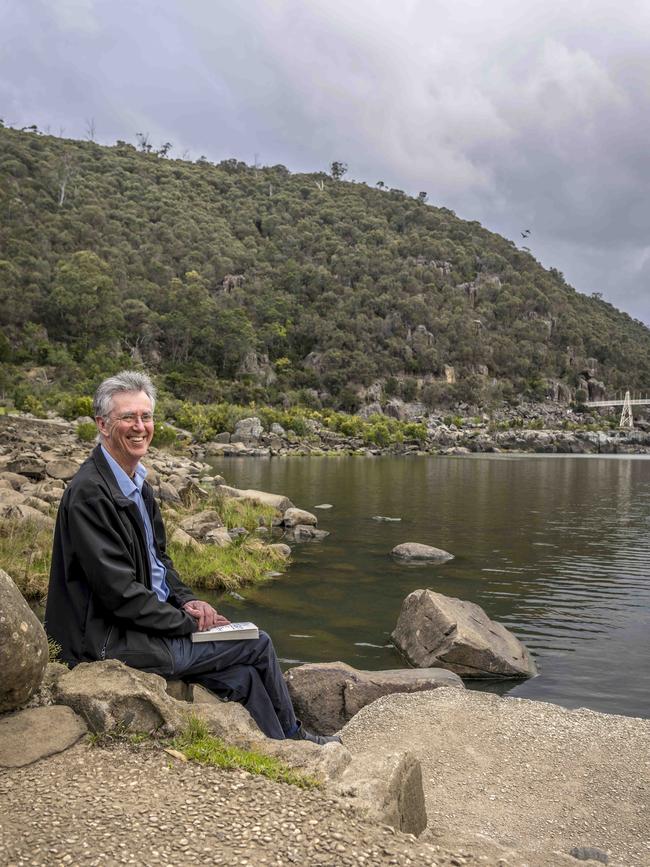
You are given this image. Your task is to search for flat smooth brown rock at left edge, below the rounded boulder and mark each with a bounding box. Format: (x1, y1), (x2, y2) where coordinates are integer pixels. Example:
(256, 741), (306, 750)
(0, 706), (88, 768)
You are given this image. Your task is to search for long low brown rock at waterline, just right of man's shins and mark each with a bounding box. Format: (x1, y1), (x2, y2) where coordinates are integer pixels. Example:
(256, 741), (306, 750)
(285, 662), (464, 735)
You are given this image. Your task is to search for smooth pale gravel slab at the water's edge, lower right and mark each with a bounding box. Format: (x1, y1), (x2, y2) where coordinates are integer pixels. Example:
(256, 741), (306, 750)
(343, 689), (650, 867)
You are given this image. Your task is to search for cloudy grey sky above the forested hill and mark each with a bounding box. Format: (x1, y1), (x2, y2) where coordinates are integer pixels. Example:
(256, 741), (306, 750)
(0, 0), (650, 325)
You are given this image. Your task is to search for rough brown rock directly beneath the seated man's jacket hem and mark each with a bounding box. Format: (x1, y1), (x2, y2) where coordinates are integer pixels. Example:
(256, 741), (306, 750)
(55, 659), (185, 735)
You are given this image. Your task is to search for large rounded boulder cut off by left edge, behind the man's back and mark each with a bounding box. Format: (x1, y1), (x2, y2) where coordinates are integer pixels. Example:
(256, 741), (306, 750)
(0, 569), (48, 713)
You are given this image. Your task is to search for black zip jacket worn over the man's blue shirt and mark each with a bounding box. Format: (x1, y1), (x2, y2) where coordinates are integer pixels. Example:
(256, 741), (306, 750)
(45, 446), (197, 675)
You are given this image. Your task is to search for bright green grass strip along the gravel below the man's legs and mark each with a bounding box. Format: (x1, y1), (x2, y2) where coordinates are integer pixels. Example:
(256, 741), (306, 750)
(172, 716), (321, 789)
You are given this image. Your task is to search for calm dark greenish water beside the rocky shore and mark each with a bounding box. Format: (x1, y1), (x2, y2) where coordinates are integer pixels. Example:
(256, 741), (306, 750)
(204, 456), (650, 717)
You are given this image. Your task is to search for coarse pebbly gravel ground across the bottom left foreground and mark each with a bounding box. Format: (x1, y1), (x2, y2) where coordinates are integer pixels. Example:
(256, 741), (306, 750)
(0, 742), (498, 867)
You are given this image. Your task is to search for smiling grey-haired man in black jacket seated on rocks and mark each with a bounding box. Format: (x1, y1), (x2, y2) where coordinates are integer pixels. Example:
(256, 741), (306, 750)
(45, 370), (339, 744)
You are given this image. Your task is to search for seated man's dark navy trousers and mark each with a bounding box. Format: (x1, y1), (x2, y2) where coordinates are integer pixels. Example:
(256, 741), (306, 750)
(166, 631), (297, 739)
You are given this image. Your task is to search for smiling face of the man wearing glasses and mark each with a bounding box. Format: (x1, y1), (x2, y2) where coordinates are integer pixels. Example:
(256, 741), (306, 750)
(95, 391), (153, 476)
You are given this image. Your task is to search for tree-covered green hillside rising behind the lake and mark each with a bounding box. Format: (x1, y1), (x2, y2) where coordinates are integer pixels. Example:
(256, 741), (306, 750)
(0, 128), (650, 410)
